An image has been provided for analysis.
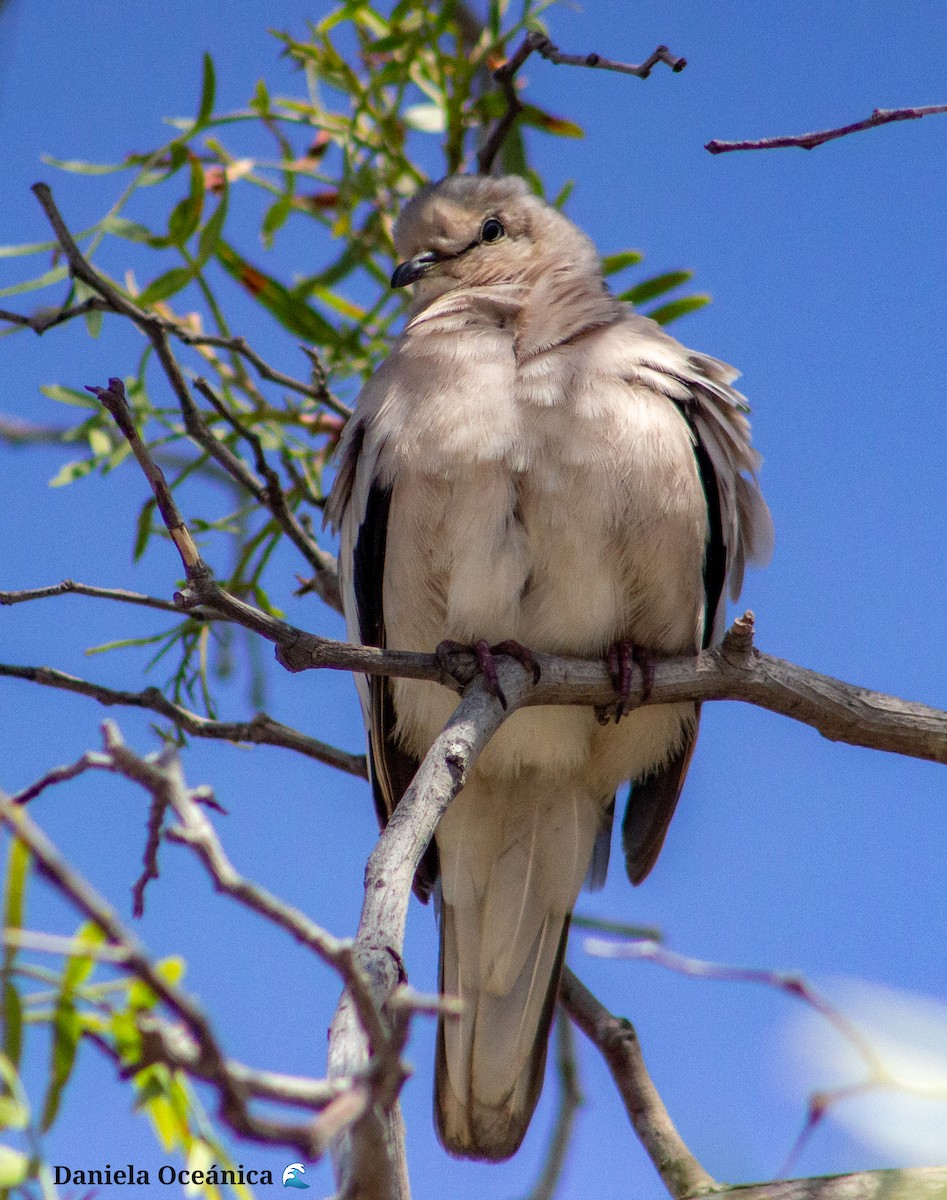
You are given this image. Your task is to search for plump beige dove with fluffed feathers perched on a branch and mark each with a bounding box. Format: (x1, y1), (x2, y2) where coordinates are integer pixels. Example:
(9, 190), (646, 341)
(326, 175), (772, 1159)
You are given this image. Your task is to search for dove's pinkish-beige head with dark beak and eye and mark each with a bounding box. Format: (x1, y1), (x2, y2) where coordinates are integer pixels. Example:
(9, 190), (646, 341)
(391, 175), (600, 308)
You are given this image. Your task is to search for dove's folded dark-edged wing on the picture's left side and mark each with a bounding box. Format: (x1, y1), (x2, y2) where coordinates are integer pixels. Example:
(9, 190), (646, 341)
(325, 406), (437, 900)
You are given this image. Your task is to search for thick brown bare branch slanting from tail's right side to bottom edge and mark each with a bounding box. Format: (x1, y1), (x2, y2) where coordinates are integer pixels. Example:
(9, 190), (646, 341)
(559, 967), (720, 1200)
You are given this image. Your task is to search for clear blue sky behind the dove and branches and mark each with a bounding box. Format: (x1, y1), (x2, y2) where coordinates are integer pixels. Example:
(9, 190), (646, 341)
(0, 0), (947, 1200)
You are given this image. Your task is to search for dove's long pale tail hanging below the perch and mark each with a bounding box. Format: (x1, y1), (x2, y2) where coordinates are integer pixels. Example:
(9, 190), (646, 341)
(434, 776), (601, 1159)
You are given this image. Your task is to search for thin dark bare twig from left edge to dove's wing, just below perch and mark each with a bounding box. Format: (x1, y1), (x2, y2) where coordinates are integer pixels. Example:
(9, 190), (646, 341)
(0, 662), (368, 779)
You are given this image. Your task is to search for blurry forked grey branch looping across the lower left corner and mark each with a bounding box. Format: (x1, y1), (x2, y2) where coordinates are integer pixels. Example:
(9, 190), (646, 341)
(0, 721), (427, 1158)
